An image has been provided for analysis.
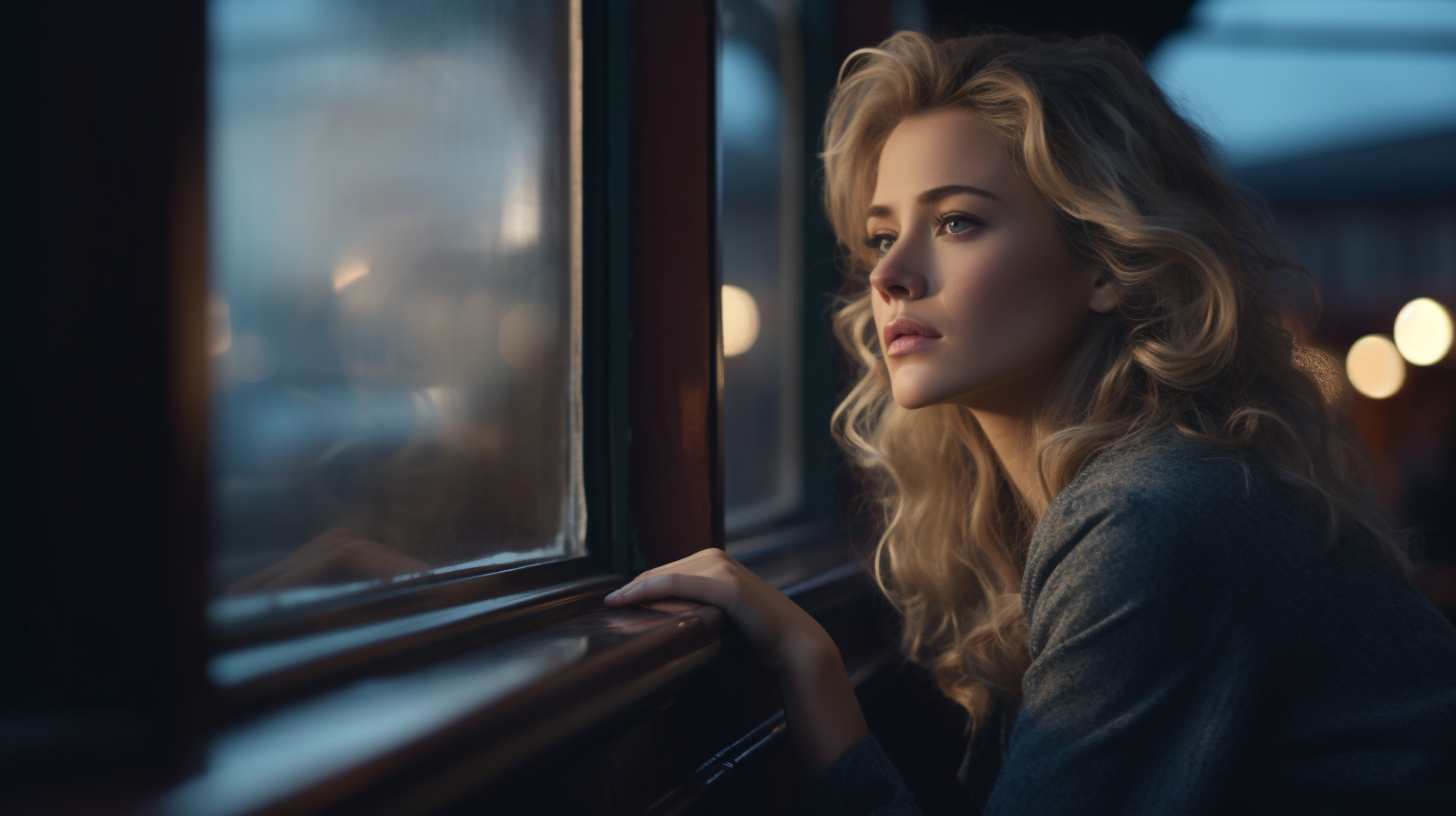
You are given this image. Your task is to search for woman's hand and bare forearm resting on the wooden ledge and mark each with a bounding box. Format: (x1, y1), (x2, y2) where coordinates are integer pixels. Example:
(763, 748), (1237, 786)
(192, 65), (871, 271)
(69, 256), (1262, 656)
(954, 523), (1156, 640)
(607, 549), (869, 778)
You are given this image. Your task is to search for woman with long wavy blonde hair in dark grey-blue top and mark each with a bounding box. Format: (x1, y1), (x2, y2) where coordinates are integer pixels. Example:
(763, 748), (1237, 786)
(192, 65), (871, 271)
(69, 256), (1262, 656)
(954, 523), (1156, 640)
(609, 34), (1456, 815)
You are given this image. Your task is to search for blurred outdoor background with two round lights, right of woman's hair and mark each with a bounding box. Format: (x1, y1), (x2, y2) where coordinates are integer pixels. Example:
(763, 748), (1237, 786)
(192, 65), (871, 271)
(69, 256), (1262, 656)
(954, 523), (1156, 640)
(1147, 0), (1456, 619)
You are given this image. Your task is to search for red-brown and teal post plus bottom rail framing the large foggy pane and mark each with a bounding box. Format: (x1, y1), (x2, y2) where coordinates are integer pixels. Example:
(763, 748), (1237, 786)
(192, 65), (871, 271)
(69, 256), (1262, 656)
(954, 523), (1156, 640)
(187, 0), (739, 708)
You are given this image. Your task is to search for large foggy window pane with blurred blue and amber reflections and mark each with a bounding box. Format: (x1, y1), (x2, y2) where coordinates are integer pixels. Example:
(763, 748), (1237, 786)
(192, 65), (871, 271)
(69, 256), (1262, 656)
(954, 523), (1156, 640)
(208, 0), (585, 624)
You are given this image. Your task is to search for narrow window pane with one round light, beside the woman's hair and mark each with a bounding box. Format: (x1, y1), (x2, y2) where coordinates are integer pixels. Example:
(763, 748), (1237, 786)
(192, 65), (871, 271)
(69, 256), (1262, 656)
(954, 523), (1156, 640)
(719, 0), (802, 533)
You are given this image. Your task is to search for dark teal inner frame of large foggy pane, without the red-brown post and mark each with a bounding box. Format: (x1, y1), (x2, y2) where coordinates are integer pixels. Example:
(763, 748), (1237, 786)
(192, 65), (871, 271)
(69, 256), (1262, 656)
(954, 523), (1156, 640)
(199, 0), (620, 707)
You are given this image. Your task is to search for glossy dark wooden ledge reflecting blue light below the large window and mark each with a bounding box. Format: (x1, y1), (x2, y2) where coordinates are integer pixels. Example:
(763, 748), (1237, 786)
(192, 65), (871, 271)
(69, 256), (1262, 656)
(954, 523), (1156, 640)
(141, 603), (722, 816)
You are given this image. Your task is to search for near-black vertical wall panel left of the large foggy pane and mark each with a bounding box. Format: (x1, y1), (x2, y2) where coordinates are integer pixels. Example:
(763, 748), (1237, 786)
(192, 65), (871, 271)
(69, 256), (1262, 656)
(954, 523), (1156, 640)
(0, 1), (205, 788)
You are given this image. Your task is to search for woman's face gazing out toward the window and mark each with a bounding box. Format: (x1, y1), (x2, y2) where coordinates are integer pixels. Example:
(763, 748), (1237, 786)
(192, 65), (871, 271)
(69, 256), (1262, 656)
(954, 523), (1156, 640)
(865, 111), (1117, 411)
